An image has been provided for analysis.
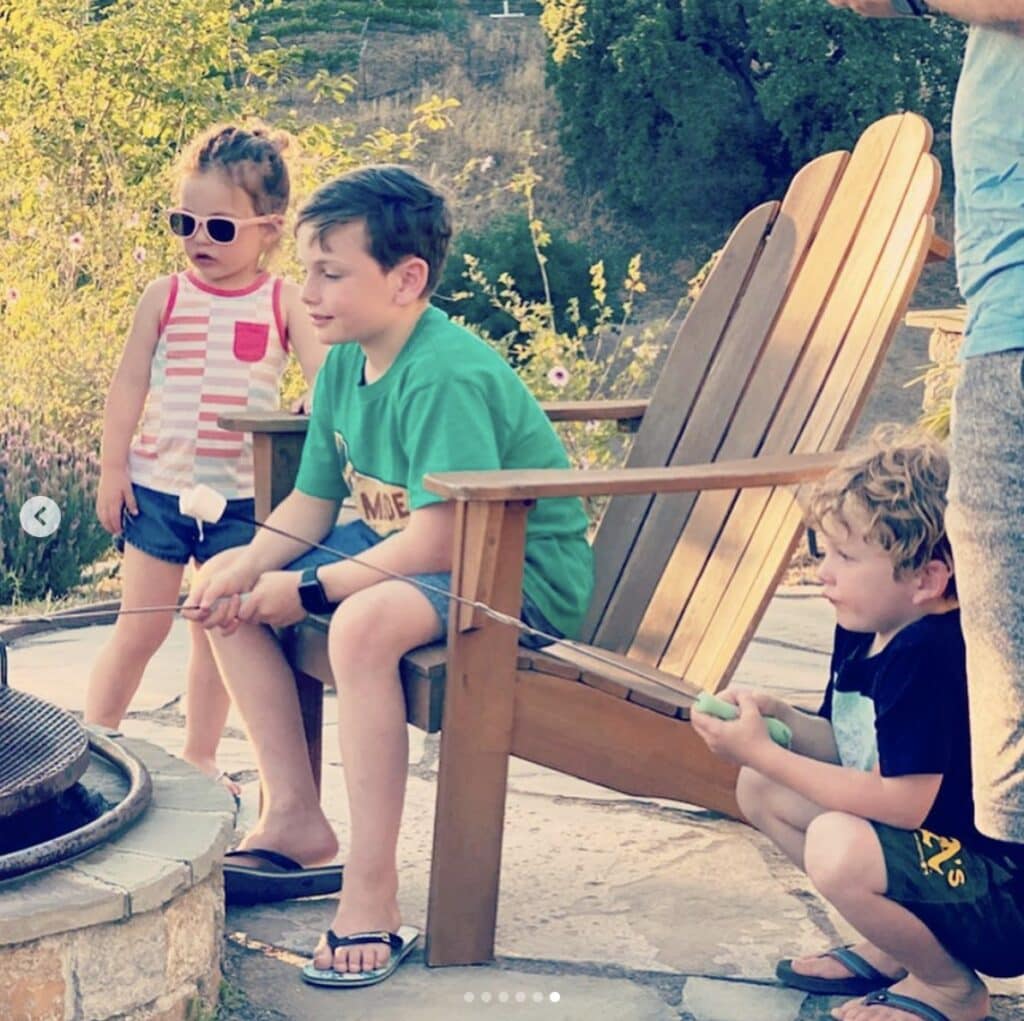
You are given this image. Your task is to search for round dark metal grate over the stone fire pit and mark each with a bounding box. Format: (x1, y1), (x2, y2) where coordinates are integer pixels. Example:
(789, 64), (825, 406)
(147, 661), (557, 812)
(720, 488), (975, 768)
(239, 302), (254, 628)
(0, 642), (89, 817)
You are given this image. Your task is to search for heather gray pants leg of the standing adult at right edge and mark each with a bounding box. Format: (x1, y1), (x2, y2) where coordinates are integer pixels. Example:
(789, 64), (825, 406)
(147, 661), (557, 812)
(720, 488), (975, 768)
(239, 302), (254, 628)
(946, 350), (1024, 843)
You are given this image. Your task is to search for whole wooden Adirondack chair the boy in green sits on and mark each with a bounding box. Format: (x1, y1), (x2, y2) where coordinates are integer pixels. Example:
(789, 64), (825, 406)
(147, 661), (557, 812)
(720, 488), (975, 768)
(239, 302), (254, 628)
(224, 109), (947, 965)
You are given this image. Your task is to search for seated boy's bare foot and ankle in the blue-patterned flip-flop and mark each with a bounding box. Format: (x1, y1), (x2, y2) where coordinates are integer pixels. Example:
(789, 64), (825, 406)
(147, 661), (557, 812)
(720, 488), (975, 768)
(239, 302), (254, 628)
(313, 870), (401, 973)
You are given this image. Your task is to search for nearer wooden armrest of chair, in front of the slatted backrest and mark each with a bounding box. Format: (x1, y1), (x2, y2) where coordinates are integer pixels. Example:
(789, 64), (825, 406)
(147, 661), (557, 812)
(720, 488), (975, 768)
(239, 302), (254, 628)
(423, 451), (843, 503)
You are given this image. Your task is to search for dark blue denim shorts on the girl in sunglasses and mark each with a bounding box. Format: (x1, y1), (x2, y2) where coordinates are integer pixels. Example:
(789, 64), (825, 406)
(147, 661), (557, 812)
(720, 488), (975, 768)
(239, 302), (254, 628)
(115, 483), (256, 564)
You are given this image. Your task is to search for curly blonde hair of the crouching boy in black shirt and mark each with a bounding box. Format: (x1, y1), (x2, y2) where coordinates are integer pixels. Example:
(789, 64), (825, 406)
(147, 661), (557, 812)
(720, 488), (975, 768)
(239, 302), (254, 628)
(806, 425), (955, 596)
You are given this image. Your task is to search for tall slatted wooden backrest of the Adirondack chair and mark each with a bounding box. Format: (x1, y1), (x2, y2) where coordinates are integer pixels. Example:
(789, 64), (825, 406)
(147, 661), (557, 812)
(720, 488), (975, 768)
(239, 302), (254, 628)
(585, 114), (939, 689)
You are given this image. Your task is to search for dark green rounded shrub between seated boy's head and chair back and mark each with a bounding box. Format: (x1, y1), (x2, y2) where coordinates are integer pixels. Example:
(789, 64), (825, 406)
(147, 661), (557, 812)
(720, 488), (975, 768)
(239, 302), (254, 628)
(434, 212), (626, 341)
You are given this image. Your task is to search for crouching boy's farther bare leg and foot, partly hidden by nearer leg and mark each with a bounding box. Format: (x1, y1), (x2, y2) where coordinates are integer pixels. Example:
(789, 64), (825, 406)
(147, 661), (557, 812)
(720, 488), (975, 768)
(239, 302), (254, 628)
(736, 767), (903, 978)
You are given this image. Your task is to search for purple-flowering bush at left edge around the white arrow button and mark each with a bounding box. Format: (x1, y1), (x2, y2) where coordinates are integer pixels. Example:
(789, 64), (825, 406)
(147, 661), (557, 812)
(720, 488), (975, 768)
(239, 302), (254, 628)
(0, 414), (111, 604)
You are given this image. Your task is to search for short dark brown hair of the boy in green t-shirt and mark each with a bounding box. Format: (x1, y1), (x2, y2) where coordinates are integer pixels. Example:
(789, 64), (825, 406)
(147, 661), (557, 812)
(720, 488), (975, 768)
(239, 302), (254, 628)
(297, 165), (452, 294)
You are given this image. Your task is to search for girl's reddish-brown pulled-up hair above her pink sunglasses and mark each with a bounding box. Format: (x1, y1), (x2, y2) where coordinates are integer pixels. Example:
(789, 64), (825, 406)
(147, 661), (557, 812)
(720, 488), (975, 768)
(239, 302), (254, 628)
(178, 124), (291, 216)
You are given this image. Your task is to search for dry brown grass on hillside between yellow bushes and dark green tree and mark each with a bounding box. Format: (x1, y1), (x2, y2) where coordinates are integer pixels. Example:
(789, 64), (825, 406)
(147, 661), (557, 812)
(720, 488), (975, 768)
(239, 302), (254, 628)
(283, 17), (693, 294)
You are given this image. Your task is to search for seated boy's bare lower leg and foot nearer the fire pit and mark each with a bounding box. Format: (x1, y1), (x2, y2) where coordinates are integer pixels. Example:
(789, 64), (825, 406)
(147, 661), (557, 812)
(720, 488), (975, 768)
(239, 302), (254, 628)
(207, 623), (338, 865)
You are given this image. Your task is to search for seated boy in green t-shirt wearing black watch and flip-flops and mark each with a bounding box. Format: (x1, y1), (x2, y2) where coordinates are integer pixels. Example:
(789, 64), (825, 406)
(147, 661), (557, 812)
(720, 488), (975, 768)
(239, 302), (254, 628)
(189, 166), (593, 986)
